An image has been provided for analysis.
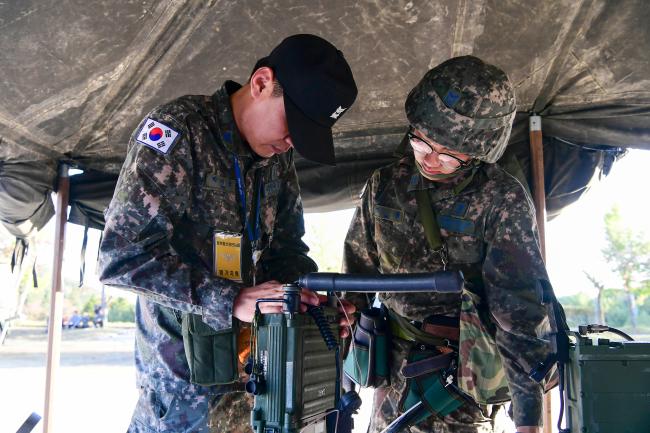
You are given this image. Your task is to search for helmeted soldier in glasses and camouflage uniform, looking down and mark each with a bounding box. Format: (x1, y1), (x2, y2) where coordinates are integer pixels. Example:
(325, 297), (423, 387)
(343, 56), (552, 433)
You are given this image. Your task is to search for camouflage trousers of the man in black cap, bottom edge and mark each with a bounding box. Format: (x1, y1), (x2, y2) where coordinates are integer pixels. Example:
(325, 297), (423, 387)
(128, 388), (253, 433)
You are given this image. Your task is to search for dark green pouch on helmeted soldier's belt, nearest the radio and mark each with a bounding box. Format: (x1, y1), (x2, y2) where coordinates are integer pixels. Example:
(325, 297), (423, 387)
(343, 308), (390, 387)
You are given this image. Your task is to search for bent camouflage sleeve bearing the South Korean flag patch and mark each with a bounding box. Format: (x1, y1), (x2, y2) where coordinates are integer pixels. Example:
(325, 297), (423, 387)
(99, 114), (241, 330)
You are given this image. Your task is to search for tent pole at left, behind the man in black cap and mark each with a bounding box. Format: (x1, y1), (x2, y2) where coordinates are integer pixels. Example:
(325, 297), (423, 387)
(43, 164), (70, 433)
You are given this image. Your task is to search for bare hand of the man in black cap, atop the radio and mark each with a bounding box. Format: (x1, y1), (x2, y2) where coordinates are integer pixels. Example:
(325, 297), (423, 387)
(232, 281), (319, 322)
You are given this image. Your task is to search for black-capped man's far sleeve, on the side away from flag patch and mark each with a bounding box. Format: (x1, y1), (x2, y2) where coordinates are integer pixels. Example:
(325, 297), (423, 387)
(262, 157), (318, 283)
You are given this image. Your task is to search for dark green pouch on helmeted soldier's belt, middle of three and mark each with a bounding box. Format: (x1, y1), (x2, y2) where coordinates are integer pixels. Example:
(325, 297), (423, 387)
(399, 343), (469, 424)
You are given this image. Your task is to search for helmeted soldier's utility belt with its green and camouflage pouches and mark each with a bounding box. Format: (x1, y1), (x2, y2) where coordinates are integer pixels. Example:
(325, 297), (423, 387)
(344, 296), (510, 425)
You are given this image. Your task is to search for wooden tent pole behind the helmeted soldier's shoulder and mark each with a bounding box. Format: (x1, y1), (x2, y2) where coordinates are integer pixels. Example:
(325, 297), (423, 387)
(528, 115), (553, 433)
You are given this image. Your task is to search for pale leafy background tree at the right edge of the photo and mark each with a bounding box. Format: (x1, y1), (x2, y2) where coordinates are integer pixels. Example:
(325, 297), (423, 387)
(603, 206), (650, 330)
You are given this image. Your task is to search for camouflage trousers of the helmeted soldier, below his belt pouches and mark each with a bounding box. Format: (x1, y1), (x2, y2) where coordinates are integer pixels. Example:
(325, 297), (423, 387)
(368, 338), (508, 433)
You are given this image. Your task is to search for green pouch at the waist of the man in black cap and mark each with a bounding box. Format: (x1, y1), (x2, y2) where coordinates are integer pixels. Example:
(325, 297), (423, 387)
(181, 313), (239, 386)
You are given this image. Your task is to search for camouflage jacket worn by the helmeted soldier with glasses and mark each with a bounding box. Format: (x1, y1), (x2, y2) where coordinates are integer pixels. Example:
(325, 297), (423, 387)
(343, 154), (550, 426)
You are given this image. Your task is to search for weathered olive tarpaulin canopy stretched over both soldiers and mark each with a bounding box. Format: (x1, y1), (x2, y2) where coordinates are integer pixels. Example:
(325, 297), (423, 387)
(0, 0), (650, 237)
